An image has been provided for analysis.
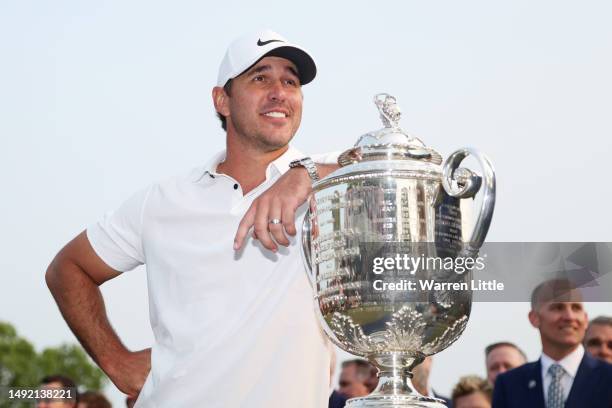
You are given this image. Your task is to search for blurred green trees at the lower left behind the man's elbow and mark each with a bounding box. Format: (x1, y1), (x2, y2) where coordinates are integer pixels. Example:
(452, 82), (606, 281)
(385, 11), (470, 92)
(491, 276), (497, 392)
(0, 321), (107, 408)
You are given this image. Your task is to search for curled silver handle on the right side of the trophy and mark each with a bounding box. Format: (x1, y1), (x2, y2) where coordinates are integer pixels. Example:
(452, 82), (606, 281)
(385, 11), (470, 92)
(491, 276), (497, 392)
(442, 147), (495, 256)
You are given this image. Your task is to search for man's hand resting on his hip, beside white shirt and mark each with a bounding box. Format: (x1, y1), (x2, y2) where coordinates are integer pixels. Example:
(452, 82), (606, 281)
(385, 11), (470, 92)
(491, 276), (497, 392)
(106, 348), (151, 398)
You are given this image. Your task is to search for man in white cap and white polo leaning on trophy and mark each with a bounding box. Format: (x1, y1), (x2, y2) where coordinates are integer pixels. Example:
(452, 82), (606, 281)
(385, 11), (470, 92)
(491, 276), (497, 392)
(46, 30), (336, 408)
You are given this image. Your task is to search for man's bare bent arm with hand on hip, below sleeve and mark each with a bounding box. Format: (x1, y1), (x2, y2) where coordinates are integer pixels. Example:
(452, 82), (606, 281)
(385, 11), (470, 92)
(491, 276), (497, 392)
(45, 232), (151, 396)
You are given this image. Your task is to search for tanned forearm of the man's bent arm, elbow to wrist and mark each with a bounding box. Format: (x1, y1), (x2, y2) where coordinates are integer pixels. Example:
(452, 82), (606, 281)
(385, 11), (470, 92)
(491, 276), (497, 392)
(45, 259), (129, 375)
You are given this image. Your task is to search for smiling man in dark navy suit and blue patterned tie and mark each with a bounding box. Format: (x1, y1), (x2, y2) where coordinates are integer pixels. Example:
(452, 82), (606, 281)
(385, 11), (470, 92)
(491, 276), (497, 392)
(493, 279), (612, 408)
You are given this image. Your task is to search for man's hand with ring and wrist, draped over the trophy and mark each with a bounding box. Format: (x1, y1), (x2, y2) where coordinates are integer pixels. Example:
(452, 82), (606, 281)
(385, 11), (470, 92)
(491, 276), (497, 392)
(234, 164), (339, 252)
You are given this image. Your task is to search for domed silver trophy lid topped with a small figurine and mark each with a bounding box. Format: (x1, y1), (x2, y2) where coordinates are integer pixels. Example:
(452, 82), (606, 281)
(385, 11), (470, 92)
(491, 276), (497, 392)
(338, 93), (442, 167)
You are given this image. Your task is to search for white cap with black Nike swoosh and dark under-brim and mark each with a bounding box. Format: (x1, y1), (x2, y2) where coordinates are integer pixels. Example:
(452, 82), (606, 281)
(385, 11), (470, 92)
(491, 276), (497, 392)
(217, 29), (317, 86)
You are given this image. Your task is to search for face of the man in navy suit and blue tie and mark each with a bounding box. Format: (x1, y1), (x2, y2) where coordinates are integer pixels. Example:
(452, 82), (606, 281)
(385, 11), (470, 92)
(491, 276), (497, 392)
(529, 301), (588, 351)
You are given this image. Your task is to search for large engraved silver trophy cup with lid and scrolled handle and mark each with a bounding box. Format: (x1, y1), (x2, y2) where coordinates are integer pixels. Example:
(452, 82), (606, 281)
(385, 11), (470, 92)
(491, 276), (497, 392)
(302, 94), (495, 408)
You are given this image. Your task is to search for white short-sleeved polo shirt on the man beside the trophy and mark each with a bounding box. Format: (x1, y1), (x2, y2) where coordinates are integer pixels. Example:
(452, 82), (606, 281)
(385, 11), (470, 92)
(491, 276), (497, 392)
(87, 148), (330, 408)
